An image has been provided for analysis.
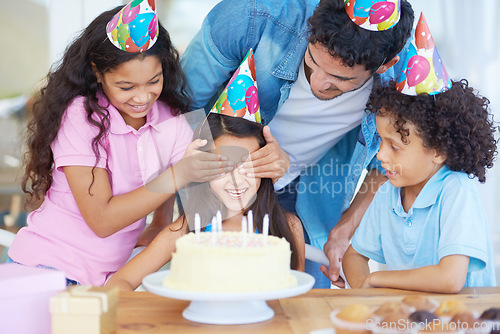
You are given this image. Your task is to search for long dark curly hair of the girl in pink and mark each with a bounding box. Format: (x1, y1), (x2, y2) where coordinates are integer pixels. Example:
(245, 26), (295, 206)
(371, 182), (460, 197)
(21, 6), (189, 206)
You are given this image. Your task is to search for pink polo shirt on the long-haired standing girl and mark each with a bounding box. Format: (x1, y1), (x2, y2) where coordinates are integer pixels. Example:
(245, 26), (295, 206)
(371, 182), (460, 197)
(9, 97), (193, 286)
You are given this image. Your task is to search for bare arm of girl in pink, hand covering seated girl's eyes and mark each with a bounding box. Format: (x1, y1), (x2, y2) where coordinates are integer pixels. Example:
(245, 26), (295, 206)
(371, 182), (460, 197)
(64, 139), (233, 238)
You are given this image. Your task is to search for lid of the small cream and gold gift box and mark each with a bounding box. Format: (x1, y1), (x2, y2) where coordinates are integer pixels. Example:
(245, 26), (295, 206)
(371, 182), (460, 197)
(50, 285), (119, 315)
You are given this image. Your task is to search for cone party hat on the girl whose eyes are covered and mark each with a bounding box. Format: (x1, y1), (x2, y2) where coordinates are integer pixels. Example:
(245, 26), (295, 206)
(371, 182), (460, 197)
(210, 49), (260, 123)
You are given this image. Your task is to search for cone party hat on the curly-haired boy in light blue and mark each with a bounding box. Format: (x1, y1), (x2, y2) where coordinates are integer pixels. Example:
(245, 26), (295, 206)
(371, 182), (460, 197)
(396, 13), (451, 95)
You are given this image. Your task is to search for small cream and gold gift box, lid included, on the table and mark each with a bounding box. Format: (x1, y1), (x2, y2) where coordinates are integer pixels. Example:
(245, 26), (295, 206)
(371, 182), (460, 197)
(50, 285), (118, 334)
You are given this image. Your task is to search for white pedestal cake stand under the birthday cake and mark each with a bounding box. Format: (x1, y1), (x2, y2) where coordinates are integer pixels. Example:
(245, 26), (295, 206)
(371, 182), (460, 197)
(142, 270), (314, 325)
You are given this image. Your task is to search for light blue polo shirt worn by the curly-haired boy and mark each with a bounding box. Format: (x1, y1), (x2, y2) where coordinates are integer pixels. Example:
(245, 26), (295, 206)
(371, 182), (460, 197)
(352, 166), (495, 287)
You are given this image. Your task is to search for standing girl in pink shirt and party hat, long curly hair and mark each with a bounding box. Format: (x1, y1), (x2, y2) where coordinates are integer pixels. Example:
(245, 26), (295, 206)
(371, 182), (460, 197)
(9, 0), (232, 285)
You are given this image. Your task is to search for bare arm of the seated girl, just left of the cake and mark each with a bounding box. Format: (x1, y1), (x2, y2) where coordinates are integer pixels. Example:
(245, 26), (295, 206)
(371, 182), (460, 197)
(106, 216), (188, 291)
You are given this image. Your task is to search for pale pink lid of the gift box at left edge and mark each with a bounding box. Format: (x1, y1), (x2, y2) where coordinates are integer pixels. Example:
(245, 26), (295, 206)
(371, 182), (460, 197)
(0, 263), (66, 299)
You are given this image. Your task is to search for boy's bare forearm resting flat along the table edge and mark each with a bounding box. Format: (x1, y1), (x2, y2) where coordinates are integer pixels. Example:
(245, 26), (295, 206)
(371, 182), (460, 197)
(362, 255), (469, 293)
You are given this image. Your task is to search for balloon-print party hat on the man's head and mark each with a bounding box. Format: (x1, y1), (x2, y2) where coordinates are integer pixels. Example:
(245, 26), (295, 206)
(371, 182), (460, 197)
(344, 0), (401, 31)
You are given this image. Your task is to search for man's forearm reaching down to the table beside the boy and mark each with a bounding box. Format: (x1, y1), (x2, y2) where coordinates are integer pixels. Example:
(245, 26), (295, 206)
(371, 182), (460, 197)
(320, 169), (387, 283)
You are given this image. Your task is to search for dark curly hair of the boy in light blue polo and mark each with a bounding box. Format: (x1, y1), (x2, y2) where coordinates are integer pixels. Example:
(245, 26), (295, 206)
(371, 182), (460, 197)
(367, 79), (496, 182)
